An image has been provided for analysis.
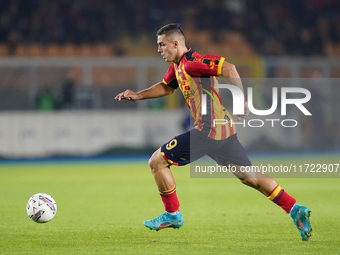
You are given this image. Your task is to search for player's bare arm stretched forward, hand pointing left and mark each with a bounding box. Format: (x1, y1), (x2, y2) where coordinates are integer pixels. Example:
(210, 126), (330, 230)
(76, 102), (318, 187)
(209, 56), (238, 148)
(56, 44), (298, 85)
(115, 82), (175, 101)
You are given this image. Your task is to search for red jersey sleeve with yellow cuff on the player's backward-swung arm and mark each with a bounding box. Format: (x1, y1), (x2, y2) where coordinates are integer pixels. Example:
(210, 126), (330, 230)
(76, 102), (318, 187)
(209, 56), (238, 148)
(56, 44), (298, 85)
(185, 55), (224, 77)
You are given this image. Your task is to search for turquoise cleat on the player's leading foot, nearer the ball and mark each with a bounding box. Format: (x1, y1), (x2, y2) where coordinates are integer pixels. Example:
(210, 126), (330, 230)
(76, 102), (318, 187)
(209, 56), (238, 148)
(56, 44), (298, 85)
(143, 212), (183, 231)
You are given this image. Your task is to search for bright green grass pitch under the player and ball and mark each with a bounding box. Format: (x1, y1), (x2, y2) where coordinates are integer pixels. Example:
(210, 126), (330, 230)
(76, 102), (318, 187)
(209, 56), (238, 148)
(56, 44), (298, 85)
(0, 154), (340, 254)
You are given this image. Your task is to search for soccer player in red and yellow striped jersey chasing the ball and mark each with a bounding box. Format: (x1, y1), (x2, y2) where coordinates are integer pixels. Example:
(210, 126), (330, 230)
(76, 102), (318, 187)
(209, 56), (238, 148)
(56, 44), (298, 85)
(115, 24), (312, 241)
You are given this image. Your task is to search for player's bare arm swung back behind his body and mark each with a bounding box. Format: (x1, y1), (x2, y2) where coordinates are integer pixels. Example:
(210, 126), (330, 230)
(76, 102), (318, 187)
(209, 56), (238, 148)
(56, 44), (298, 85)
(222, 62), (250, 121)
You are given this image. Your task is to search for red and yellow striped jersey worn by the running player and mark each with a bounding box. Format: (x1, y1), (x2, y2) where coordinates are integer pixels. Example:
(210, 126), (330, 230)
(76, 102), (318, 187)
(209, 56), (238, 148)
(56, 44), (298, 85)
(163, 48), (236, 140)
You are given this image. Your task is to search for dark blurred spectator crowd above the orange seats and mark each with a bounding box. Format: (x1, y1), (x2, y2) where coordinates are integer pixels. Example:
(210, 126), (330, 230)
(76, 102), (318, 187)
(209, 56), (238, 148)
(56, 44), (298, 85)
(0, 0), (340, 56)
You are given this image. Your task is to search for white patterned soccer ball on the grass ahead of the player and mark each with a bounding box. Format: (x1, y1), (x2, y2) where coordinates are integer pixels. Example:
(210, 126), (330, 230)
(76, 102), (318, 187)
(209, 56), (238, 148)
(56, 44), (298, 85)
(26, 193), (57, 223)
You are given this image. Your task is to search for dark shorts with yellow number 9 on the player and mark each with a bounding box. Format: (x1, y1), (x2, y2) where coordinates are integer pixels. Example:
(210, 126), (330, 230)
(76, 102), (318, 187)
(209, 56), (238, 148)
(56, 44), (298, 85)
(161, 129), (251, 166)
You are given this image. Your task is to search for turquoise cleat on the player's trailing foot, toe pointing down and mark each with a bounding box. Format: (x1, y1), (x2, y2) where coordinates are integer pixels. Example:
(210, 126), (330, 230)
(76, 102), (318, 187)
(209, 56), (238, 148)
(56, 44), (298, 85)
(290, 205), (313, 241)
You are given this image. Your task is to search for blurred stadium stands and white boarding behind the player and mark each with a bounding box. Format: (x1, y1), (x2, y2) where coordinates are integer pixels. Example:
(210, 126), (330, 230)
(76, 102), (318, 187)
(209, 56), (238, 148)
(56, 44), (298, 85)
(0, 0), (340, 158)
